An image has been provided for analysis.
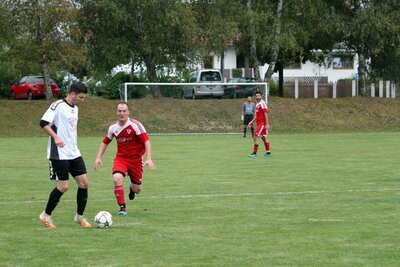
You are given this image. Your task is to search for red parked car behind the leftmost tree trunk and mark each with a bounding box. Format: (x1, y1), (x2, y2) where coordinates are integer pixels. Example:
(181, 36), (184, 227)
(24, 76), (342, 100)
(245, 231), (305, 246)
(10, 76), (61, 100)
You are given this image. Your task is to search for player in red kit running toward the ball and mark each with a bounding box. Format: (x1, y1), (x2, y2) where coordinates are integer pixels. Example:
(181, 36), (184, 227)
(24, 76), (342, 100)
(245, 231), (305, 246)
(94, 102), (156, 216)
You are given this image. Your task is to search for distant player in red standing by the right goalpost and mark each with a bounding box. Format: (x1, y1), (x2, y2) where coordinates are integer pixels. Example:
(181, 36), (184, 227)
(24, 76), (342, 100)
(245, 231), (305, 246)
(248, 92), (272, 158)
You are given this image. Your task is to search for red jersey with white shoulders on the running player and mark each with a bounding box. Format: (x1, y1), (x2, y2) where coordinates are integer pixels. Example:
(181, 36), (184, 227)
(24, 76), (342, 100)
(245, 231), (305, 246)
(103, 119), (149, 158)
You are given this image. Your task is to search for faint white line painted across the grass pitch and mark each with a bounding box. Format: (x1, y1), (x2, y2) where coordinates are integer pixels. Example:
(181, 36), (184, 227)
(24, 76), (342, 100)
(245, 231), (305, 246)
(0, 188), (400, 205)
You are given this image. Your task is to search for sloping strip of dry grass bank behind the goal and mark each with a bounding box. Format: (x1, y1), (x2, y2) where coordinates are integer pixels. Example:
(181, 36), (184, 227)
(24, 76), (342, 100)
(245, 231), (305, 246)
(0, 97), (400, 137)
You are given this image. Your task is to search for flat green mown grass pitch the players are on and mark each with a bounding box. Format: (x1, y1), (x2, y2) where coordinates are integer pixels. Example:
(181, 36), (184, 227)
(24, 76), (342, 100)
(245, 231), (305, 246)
(0, 132), (400, 266)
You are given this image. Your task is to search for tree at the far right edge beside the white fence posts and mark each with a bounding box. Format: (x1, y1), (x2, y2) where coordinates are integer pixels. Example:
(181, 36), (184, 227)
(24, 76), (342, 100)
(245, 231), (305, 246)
(334, 0), (400, 95)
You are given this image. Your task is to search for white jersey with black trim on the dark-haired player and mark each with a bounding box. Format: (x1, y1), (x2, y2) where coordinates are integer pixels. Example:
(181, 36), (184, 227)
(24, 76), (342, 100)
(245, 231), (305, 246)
(42, 99), (81, 160)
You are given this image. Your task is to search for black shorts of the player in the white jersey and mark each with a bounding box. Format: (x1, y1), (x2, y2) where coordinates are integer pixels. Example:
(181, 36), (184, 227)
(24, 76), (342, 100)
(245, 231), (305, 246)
(49, 157), (87, 181)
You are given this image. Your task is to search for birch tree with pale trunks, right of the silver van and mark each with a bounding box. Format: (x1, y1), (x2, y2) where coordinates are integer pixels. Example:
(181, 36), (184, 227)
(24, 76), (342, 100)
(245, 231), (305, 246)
(237, 0), (337, 95)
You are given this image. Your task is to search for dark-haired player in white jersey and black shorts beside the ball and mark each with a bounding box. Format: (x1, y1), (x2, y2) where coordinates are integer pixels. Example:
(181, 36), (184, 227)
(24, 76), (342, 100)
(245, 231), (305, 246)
(39, 82), (92, 228)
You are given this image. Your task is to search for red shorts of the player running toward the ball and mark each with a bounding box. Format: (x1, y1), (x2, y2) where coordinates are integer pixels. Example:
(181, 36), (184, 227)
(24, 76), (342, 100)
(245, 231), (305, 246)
(113, 157), (143, 184)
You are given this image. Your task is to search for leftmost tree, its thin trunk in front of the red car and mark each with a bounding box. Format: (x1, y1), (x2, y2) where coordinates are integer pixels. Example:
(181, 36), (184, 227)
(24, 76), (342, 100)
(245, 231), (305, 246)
(7, 0), (85, 99)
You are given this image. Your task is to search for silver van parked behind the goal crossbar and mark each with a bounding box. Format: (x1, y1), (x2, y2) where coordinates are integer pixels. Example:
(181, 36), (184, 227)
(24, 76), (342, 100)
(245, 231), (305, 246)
(182, 69), (224, 99)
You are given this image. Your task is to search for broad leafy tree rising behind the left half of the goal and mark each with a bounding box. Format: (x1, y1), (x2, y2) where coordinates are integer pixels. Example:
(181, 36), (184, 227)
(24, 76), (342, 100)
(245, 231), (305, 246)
(80, 0), (198, 98)
